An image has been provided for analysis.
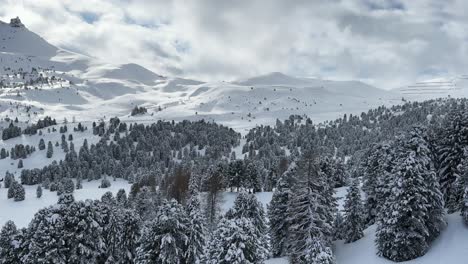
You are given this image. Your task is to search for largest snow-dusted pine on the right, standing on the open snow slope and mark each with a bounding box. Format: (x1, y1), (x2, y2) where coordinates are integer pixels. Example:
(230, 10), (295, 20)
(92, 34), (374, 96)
(376, 129), (444, 261)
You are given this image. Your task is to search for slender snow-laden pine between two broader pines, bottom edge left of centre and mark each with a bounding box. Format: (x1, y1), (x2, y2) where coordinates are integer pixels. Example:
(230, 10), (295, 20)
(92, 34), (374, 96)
(185, 195), (207, 264)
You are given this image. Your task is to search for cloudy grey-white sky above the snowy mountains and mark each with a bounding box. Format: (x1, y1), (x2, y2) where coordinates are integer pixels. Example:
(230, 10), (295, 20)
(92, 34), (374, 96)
(0, 0), (468, 89)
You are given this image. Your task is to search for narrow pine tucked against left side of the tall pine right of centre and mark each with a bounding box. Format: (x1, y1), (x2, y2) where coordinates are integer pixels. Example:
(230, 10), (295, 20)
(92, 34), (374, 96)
(268, 163), (296, 257)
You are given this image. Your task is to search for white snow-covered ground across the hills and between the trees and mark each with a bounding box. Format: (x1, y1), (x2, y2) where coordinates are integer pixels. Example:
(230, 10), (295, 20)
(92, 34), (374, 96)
(0, 17), (468, 264)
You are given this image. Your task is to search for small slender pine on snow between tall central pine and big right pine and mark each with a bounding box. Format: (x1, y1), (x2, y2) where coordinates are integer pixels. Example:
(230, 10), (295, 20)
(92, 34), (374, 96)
(342, 178), (365, 243)
